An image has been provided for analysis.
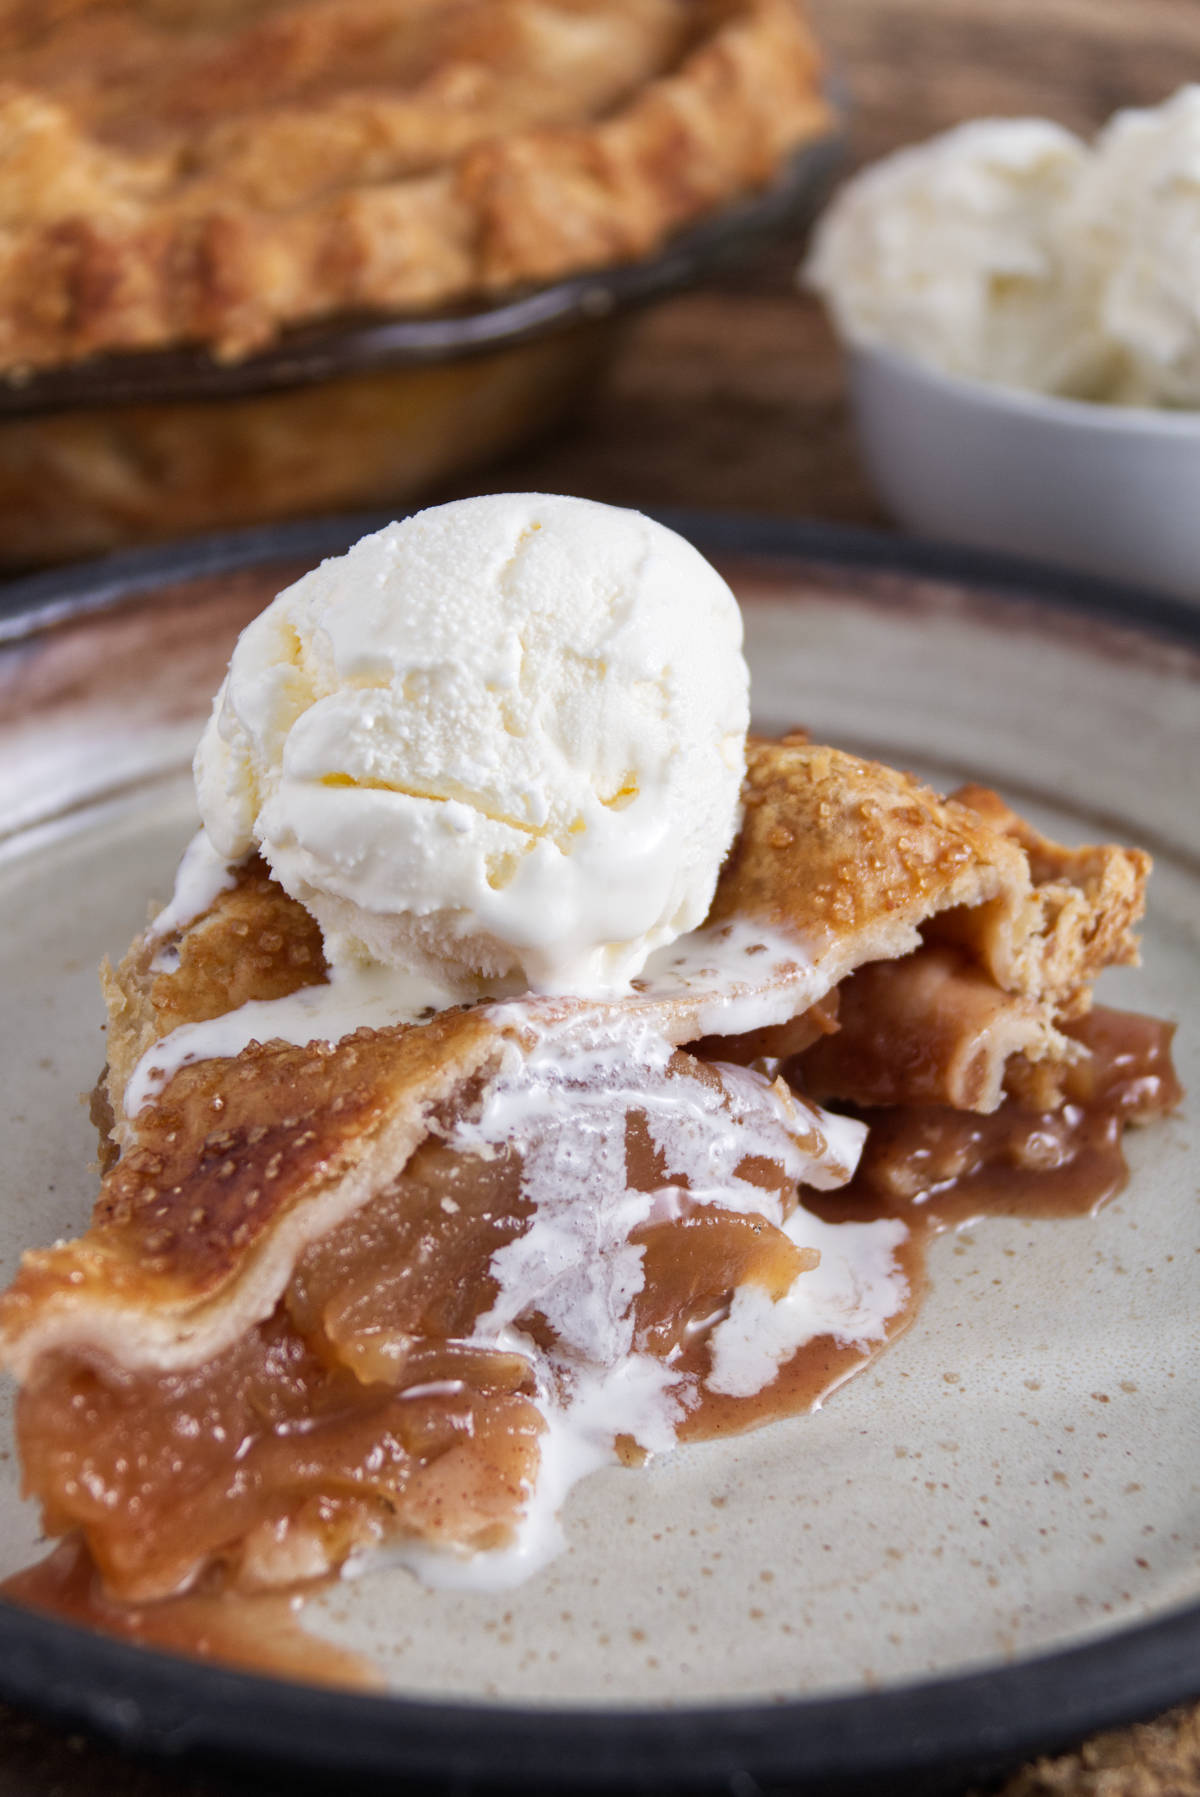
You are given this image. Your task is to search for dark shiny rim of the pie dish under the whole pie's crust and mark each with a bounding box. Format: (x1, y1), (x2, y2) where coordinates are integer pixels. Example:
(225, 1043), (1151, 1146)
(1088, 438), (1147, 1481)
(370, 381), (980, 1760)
(0, 131), (844, 419)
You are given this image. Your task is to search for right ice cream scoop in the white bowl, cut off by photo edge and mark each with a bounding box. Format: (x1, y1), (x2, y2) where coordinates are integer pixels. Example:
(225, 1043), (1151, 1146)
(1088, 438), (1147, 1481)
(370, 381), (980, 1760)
(1071, 86), (1200, 406)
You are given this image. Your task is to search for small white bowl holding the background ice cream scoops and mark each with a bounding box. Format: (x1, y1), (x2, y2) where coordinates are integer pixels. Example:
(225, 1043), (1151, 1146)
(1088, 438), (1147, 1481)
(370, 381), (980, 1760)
(848, 345), (1200, 600)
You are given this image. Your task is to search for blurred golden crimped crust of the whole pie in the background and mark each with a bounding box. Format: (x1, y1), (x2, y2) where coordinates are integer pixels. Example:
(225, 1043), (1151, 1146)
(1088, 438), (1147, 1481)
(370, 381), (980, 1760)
(0, 0), (830, 370)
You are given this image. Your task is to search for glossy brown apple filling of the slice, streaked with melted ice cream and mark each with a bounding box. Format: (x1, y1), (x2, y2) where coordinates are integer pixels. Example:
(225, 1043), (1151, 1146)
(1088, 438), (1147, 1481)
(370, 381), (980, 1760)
(18, 1010), (1180, 1601)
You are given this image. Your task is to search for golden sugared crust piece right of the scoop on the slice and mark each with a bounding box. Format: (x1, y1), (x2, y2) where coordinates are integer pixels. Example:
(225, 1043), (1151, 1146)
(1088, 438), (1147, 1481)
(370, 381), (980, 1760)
(711, 735), (1150, 1022)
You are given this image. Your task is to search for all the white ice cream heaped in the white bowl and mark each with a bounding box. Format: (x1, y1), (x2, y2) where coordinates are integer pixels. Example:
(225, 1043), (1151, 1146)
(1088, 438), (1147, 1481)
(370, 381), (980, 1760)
(803, 86), (1200, 406)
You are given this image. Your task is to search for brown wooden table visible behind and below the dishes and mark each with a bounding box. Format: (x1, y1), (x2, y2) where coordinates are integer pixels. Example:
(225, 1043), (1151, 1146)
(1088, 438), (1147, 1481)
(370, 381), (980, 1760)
(0, 0), (1200, 1797)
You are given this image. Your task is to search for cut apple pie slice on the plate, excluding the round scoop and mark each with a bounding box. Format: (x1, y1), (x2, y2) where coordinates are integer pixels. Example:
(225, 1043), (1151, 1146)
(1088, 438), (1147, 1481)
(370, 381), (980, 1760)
(0, 735), (1178, 1601)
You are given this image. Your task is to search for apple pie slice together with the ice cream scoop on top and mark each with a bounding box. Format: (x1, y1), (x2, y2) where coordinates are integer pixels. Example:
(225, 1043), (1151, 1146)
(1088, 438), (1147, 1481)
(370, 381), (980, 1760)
(0, 498), (1178, 1646)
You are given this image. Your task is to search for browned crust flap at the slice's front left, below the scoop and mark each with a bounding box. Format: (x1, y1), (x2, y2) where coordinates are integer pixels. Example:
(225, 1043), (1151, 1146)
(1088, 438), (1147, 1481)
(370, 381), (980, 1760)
(0, 1012), (501, 1369)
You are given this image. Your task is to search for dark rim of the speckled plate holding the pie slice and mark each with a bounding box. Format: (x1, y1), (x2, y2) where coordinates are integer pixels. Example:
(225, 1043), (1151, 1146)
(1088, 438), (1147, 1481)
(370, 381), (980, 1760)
(0, 512), (1200, 1797)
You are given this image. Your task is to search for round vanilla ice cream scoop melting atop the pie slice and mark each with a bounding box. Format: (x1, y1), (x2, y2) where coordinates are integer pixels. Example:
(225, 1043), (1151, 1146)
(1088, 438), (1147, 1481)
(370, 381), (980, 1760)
(196, 494), (747, 997)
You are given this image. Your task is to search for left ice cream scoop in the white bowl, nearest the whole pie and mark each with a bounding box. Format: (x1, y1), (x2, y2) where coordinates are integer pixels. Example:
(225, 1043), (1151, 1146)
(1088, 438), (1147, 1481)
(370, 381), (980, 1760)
(803, 119), (1107, 392)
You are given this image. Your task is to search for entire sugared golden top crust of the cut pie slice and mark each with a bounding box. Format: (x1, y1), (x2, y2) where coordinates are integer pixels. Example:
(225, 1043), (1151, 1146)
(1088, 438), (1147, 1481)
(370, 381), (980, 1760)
(0, 735), (1150, 1377)
